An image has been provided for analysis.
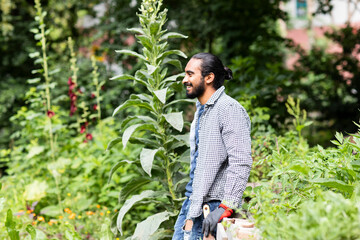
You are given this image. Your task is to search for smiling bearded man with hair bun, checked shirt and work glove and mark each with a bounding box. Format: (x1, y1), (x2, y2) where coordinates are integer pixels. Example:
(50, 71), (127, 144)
(173, 53), (252, 240)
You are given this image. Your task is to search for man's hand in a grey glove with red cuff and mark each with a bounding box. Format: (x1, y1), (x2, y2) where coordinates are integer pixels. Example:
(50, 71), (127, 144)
(202, 204), (233, 237)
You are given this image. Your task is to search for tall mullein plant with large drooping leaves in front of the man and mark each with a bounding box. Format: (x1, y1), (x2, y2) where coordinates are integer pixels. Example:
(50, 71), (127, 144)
(108, 0), (192, 239)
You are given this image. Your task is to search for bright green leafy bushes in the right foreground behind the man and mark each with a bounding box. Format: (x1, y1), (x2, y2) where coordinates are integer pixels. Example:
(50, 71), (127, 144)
(248, 100), (360, 239)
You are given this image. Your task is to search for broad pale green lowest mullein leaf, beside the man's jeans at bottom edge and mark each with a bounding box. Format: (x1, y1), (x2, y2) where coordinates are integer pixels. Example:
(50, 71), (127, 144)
(132, 211), (171, 240)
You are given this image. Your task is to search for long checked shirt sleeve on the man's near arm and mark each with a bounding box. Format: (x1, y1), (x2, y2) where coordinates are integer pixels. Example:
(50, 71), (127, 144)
(221, 104), (252, 209)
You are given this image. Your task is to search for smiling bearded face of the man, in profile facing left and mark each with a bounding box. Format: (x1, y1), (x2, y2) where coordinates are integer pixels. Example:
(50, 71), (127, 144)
(182, 58), (205, 98)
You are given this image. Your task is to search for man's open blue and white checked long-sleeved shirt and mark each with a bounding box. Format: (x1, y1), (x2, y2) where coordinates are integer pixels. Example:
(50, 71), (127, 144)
(186, 86), (252, 219)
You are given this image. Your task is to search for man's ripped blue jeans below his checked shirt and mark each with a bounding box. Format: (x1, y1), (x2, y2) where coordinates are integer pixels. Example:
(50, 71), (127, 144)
(172, 198), (221, 240)
